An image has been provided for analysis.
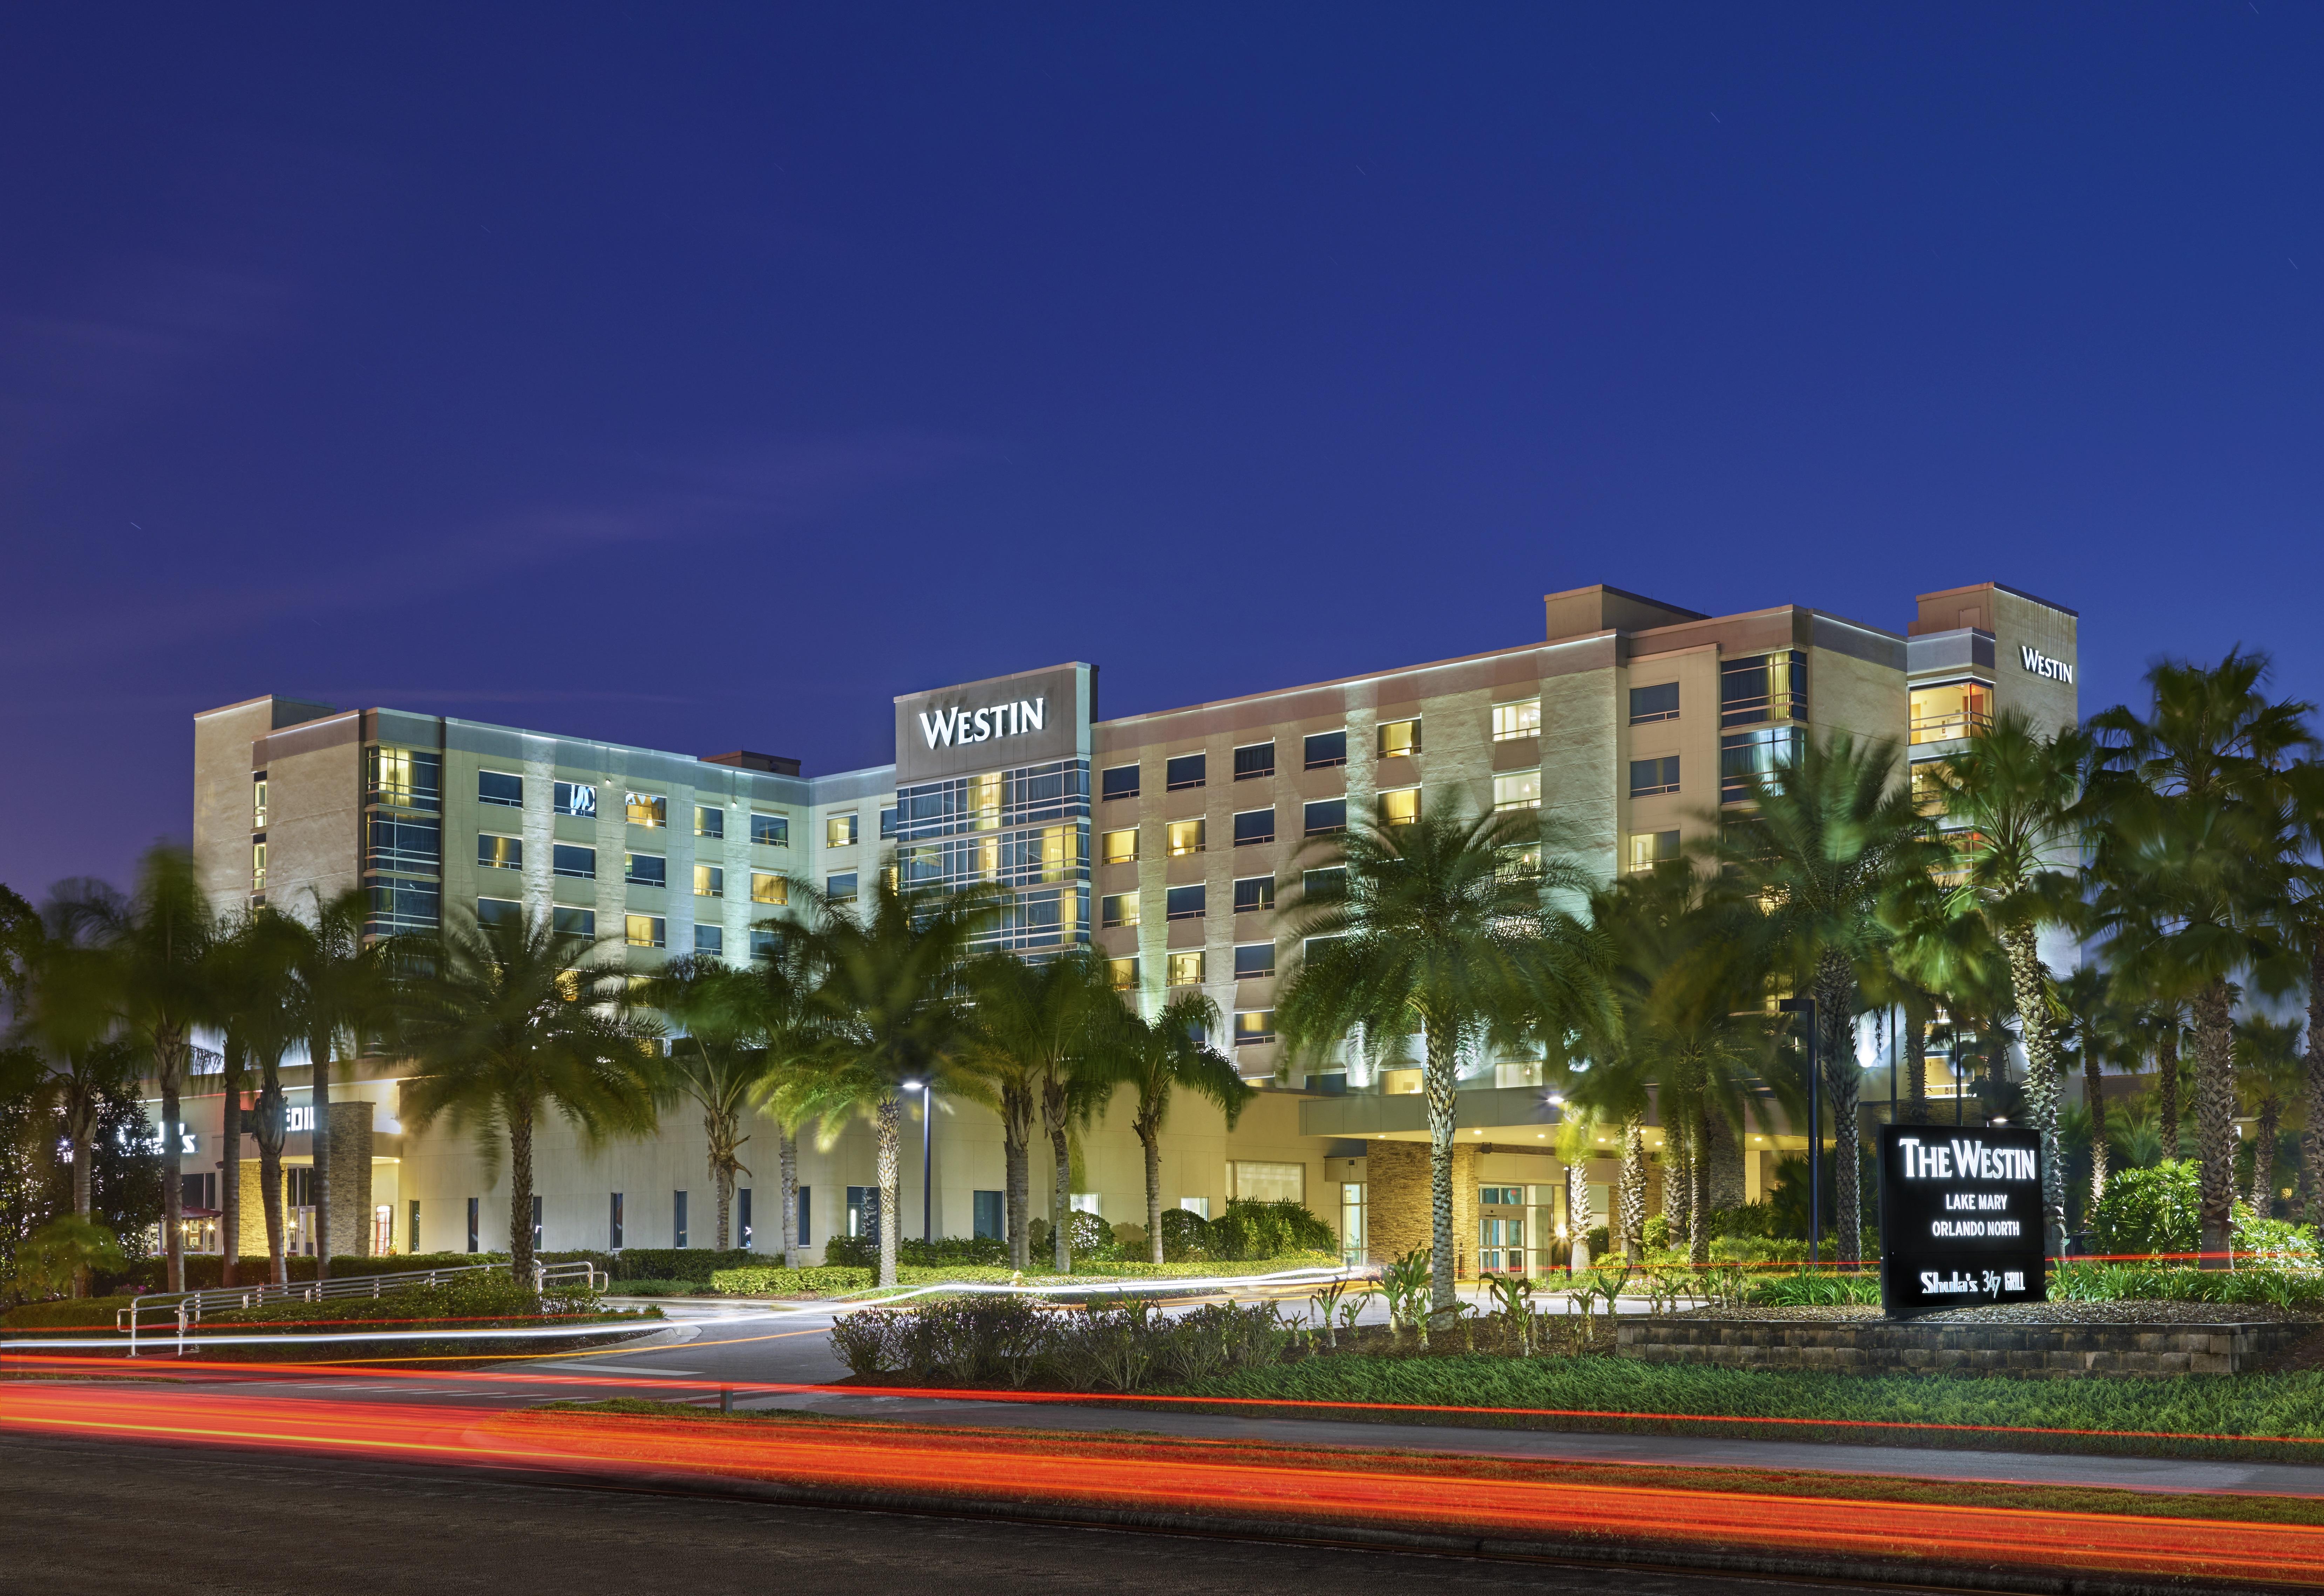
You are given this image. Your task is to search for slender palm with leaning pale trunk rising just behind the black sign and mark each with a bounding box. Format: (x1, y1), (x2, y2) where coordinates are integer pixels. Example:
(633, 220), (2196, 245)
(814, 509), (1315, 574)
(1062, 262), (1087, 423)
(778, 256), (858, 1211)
(1934, 709), (2089, 1257)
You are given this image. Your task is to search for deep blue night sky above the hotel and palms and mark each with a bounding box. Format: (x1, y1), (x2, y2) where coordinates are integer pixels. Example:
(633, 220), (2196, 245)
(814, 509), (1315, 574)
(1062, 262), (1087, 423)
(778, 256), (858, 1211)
(0, 0), (2324, 894)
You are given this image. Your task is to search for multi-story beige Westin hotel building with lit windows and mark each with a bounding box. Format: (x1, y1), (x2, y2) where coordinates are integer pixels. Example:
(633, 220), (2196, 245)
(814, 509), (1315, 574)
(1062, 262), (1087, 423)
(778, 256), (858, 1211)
(177, 583), (2078, 1268)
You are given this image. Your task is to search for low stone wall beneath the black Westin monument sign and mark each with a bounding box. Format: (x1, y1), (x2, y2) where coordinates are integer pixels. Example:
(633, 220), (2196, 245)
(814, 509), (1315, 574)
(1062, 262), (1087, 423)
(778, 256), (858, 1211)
(1615, 1317), (2315, 1380)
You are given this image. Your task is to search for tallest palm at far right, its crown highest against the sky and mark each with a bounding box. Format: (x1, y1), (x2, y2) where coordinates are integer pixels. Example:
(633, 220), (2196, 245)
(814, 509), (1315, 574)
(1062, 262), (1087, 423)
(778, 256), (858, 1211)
(2092, 650), (2315, 1268)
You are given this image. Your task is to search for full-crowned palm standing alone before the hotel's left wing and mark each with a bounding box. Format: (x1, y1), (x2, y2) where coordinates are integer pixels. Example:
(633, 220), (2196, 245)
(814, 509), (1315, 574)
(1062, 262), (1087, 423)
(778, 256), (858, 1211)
(390, 908), (655, 1280)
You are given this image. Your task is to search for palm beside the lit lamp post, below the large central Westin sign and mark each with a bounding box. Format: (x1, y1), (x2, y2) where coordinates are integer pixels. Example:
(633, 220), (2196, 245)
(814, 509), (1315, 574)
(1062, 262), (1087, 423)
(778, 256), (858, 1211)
(753, 871), (995, 1285)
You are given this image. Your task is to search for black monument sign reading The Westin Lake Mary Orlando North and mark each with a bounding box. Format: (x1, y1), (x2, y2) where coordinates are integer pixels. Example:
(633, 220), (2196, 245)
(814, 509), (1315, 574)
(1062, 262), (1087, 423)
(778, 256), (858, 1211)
(1880, 1124), (2047, 1317)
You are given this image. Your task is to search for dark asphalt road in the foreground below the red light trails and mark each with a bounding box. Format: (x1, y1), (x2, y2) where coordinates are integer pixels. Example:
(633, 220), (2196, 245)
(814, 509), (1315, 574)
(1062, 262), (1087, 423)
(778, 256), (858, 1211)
(0, 1433), (1924, 1596)
